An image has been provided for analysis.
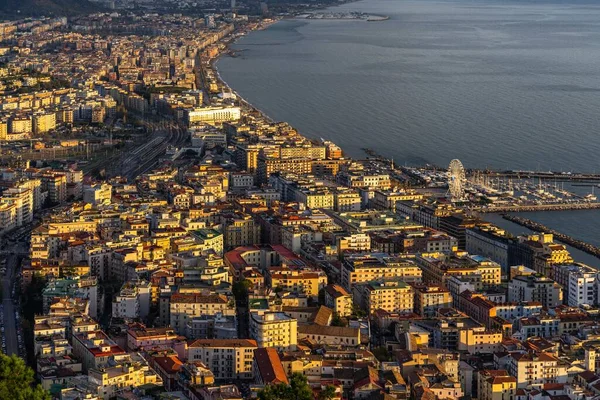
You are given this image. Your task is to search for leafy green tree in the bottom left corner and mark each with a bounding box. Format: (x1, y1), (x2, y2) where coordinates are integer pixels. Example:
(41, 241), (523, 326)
(0, 354), (51, 400)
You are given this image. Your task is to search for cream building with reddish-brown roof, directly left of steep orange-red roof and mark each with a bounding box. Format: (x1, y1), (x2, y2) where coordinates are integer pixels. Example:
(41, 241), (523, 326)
(188, 339), (257, 379)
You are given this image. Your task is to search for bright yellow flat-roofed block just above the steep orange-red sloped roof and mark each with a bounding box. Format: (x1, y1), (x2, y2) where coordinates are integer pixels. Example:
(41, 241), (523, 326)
(250, 312), (298, 350)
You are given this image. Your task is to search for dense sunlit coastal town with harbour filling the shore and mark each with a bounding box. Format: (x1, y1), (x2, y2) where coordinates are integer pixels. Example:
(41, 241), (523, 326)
(0, 0), (600, 400)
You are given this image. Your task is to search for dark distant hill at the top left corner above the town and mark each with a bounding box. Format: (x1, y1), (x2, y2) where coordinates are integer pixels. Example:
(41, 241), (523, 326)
(0, 0), (103, 19)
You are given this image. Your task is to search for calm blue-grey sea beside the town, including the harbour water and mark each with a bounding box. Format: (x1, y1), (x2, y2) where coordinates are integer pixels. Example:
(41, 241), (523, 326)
(217, 0), (600, 266)
